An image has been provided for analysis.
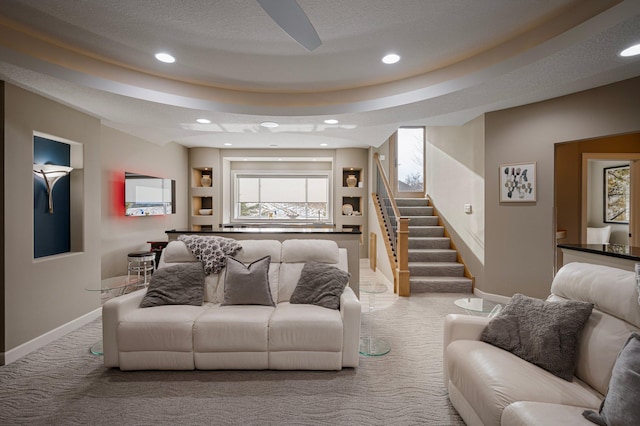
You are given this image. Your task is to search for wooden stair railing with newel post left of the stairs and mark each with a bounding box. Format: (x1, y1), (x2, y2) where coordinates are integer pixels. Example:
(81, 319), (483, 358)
(372, 152), (411, 296)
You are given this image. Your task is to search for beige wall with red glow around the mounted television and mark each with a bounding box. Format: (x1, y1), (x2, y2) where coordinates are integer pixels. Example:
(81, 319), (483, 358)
(98, 126), (189, 278)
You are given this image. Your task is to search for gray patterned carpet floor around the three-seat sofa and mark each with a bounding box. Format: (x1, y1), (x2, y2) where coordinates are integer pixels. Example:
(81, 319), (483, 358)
(0, 294), (464, 425)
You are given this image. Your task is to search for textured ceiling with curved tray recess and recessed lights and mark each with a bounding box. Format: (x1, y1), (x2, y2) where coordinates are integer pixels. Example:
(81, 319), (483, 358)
(0, 0), (640, 148)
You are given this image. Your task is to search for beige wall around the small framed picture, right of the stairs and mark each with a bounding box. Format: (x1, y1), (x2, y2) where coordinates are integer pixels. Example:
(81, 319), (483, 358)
(480, 78), (640, 297)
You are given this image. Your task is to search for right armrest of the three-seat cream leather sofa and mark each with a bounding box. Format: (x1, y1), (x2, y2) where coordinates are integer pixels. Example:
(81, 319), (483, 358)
(340, 287), (362, 367)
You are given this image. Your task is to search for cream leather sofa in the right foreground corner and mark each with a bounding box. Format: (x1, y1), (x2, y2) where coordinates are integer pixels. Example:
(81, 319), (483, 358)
(444, 263), (640, 426)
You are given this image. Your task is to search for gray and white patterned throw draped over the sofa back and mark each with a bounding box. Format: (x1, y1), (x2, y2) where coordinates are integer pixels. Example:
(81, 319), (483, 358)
(178, 235), (242, 275)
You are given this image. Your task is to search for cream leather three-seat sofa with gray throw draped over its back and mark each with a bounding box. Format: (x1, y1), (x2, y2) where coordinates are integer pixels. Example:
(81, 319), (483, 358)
(102, 240), (361, 370)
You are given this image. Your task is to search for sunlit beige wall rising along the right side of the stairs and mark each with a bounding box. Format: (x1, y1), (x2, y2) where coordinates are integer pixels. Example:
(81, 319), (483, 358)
(425, 116), (485, 288)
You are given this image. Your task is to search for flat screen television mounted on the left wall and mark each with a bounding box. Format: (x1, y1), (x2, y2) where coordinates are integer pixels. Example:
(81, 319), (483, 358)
(124, 172), (176, 216)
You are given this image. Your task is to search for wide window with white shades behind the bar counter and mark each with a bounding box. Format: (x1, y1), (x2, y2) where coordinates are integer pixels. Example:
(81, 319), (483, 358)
(234, 173), (330, 221)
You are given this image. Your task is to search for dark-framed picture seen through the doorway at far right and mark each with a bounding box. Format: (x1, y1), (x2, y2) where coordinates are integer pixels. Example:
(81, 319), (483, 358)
(604, 166), (630, 223)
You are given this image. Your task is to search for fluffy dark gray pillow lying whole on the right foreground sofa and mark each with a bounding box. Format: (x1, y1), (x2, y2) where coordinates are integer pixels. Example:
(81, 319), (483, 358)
(481, 294), (593, 381)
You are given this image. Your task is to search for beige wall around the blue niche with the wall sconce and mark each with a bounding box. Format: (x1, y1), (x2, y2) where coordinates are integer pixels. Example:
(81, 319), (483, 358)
(2, 84), (101, 351)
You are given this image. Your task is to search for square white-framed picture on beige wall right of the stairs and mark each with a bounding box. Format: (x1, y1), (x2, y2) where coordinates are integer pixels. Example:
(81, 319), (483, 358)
(499, 163), (536, 203)
